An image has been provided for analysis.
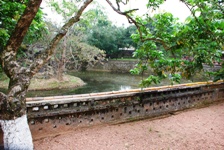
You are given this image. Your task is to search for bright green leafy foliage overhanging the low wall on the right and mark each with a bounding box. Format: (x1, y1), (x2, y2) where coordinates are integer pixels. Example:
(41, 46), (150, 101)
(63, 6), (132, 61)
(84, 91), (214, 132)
(131, 0), (224, 87)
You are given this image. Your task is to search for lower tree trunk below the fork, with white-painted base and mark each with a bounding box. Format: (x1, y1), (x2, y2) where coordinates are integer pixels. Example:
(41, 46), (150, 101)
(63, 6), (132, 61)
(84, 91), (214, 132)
(0, 70), (33, 150)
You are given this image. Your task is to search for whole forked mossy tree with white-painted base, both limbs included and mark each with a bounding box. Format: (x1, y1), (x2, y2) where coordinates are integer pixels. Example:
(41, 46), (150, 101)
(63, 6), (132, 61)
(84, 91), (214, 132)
(0, 0), (93, 149)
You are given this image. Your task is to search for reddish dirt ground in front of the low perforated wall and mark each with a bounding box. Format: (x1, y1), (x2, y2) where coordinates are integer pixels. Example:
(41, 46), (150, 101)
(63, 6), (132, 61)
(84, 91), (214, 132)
(34, 102), (224, 150)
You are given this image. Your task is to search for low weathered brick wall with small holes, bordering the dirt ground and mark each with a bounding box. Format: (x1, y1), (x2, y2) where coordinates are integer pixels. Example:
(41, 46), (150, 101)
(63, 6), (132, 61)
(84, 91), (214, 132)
(27, 82), (224, 139)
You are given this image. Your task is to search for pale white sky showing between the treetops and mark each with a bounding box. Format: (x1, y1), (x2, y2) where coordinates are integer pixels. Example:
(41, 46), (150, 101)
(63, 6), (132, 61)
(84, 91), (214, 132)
(41, 0), (190, 26)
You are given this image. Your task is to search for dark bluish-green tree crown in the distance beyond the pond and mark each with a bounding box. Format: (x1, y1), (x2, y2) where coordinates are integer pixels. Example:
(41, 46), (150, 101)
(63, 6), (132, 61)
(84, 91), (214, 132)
(87, 17), (137, 58)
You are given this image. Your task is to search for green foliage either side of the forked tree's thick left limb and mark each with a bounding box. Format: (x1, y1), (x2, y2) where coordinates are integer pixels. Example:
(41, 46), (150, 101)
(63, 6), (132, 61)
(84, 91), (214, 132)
(0, 0), (45, 49)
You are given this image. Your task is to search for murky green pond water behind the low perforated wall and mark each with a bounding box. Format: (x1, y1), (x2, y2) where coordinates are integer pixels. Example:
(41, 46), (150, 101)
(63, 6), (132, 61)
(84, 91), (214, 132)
(27, 71), (206, 97)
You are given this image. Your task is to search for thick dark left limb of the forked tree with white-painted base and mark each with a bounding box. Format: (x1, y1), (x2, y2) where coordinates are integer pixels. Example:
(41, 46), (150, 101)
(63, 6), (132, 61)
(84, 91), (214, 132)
(0, 0), (42, 77)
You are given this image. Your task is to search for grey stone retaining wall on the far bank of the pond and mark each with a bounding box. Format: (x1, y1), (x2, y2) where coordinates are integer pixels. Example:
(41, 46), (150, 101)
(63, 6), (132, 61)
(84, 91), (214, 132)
(87, 60), (137, 73)
